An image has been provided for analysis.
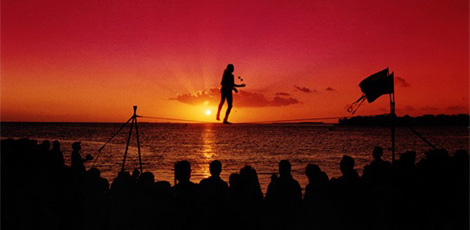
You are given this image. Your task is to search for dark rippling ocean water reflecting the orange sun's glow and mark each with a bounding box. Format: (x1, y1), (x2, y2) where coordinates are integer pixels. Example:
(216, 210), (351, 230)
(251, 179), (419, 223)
(1, 123), (469, 192)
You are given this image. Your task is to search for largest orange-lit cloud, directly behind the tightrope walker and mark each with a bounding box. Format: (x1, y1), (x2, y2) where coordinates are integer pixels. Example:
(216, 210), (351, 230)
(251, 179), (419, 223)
(170, 88), (300, 108)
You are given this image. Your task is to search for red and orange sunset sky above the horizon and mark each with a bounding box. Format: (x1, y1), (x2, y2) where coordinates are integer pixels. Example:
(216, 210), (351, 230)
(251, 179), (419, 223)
(1, 0), (469, 122)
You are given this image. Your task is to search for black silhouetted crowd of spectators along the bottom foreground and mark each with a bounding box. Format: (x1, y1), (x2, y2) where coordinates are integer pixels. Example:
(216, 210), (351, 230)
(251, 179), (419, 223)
(1, 139), (469, 230)
